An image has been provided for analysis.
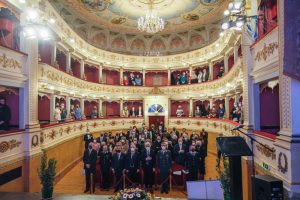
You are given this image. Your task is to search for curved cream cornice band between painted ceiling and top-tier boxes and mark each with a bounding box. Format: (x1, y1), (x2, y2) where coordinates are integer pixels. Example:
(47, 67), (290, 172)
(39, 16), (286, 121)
(41, 1), (240, 69)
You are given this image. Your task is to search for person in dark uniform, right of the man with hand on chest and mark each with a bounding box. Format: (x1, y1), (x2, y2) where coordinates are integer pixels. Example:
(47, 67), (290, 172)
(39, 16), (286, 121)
(156, 142), (172, 194)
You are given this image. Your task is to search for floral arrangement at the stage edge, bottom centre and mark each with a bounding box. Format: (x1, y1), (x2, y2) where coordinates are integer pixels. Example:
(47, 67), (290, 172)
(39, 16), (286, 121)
(113, 188), (154, 200)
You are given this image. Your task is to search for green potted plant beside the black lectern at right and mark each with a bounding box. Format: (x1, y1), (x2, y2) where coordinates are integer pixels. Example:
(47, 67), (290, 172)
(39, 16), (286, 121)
(216, 156), (231, 200)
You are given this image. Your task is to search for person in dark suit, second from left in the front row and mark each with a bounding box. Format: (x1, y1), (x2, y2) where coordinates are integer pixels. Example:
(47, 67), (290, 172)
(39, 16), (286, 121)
(99, 145), (112, 190)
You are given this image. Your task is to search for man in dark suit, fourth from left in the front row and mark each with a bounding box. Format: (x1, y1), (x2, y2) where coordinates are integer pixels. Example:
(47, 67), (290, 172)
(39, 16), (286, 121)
(125, 143), (140, 186)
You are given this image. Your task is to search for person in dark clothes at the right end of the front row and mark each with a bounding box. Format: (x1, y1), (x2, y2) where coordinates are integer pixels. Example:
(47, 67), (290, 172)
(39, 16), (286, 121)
(186, 145), (200, 181)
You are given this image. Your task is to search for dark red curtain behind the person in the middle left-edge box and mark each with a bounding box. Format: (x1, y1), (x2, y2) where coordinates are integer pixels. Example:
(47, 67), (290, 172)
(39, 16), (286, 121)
(0, 90), (19, 127)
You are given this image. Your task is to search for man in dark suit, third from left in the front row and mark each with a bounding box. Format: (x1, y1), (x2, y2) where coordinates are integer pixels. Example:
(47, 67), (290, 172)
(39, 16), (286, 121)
(112, 143), (125, 192)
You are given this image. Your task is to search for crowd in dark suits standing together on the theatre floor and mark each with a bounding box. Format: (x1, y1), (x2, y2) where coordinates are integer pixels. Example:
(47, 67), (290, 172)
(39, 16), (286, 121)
(83, 125), (208, 193)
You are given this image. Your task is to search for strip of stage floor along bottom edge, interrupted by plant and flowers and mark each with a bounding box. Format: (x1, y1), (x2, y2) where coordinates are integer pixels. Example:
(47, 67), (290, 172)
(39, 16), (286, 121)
(0, 192), (183, 200)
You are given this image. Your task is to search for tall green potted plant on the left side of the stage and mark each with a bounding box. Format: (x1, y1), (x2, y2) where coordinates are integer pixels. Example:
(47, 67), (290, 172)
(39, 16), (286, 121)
(38, 150), (57, 200)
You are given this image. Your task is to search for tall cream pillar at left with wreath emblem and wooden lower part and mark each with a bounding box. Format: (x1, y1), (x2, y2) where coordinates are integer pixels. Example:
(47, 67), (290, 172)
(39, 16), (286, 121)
(17, 10), (41, 192)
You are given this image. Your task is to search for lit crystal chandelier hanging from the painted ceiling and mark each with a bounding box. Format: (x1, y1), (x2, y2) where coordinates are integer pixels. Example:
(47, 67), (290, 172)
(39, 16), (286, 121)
(138, 0), (165, 34)
